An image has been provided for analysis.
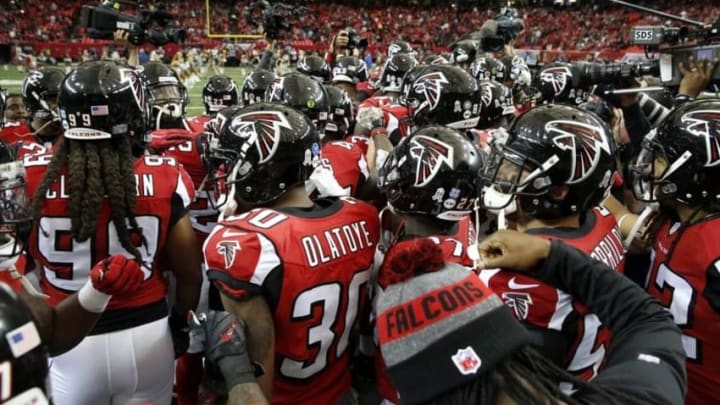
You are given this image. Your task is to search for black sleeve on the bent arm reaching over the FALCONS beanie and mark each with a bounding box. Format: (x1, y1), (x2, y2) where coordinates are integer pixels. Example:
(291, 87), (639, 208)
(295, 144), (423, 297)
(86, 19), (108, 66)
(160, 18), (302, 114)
(536, 241), (687, 404)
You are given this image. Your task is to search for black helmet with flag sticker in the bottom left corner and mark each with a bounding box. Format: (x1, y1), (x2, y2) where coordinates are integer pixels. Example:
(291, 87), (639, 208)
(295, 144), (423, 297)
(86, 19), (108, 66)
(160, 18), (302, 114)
(0, 283), (48, 404)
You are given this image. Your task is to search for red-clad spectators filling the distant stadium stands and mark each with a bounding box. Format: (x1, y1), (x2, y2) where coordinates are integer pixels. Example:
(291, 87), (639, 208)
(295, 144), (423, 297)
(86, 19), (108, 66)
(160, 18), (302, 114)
(0, 0), (720, 54)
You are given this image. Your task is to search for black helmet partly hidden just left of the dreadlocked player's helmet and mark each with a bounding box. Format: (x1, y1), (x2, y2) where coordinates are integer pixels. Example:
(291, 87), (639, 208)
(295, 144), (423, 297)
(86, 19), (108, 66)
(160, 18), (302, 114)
(22, 67), (65, 121)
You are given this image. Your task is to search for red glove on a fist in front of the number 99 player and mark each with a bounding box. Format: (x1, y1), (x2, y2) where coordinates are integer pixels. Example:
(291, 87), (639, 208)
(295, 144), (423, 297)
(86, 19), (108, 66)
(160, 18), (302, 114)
(90, 255), (145, 295)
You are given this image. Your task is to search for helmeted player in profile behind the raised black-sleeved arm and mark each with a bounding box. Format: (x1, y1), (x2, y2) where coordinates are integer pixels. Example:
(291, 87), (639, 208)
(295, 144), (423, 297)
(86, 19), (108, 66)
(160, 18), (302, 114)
(480, 105), (624, 379)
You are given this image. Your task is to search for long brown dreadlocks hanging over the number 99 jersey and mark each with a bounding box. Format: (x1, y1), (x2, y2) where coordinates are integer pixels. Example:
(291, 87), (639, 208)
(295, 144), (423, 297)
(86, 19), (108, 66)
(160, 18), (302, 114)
(32, 137), (145, 263)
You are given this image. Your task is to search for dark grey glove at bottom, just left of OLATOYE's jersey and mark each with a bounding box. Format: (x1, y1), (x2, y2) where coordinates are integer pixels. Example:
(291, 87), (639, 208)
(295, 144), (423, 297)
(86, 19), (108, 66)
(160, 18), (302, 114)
(191, 310), (262, 390)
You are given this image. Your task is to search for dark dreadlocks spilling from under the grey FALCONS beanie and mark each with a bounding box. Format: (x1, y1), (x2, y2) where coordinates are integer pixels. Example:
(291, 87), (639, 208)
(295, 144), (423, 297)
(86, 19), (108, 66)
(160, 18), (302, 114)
(425, 346), (645, 405)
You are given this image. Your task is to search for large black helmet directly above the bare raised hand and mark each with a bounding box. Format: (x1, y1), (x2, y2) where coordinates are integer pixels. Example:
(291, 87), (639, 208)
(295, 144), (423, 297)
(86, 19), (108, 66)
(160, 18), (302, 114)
(482, 105), (616, 219)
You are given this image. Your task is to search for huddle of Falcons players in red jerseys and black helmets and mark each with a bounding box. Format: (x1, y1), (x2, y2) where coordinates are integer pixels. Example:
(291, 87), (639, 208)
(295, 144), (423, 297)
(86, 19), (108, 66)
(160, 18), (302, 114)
(0, 15), (720, 405)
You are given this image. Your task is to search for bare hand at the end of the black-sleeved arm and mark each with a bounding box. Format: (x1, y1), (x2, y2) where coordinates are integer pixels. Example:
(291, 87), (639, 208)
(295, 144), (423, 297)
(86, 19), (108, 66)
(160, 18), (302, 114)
(478, 230), (550, 271)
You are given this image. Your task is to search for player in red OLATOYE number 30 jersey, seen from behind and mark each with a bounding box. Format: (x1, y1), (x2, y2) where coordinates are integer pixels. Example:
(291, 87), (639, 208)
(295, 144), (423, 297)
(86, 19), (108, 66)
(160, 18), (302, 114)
(204, 102), (378, 404)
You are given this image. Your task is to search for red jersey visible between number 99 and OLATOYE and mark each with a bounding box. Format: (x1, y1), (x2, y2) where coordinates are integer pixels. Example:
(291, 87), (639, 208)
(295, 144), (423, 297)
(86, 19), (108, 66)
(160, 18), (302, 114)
(150, 129), (219, 238)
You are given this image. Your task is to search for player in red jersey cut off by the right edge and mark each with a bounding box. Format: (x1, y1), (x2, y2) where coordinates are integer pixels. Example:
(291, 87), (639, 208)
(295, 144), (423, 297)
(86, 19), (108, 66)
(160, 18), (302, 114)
(616, 99), (720, 404)
